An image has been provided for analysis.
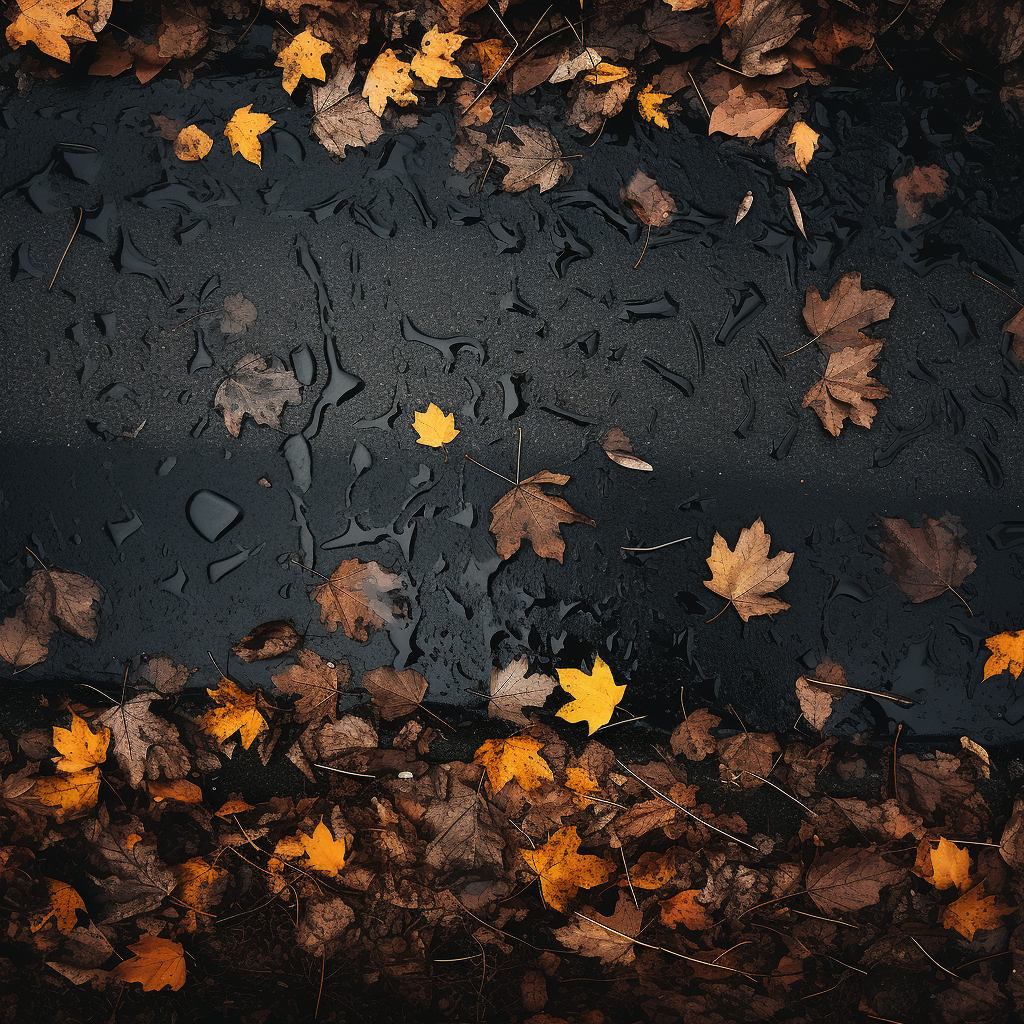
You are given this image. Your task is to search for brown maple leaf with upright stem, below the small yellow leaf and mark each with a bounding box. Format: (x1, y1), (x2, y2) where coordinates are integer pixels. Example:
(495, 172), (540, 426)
(490, 469), (596, 562)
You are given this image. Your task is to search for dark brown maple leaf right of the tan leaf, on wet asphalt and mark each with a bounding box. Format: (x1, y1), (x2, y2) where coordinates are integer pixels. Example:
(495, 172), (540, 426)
(880, 512), (978, 614)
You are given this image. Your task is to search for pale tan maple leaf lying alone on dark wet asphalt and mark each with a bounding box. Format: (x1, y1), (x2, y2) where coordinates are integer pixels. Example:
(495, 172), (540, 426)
(705, 519), (793, 623)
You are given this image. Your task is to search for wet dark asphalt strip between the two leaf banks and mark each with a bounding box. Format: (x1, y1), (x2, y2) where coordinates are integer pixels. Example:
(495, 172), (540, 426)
(0, 46), (1024, 756)
